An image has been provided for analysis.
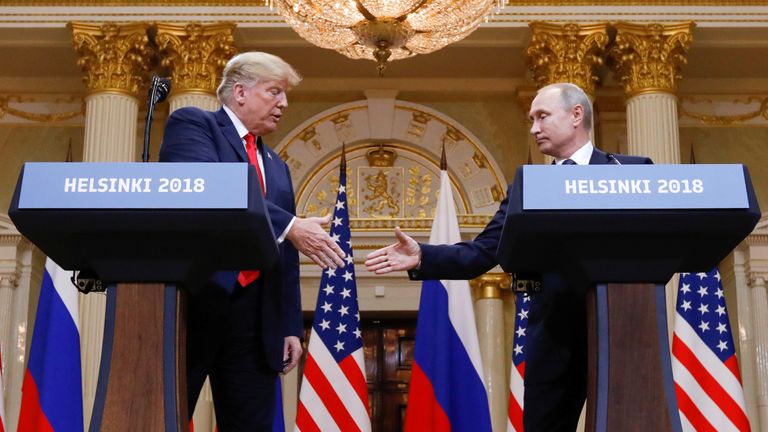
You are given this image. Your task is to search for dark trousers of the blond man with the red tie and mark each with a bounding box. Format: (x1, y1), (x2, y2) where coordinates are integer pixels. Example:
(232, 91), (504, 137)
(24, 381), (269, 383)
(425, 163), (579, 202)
(187, 281), (277, 432)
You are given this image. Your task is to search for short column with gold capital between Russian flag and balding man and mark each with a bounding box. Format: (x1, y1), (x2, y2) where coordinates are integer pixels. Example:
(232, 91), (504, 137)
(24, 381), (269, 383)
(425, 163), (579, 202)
(470, 273), (512, 431)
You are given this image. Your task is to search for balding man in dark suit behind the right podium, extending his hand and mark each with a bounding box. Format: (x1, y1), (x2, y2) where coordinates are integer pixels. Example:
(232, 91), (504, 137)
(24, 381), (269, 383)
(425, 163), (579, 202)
(366, 83), (652, 432)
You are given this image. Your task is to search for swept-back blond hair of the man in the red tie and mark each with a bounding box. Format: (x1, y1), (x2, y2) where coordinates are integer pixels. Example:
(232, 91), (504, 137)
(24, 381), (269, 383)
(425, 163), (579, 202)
(216, 51), (301, 104)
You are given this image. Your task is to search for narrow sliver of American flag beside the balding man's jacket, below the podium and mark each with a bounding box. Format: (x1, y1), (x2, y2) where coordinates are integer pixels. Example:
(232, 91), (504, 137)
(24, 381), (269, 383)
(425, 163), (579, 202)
(507, 293), (531, 432)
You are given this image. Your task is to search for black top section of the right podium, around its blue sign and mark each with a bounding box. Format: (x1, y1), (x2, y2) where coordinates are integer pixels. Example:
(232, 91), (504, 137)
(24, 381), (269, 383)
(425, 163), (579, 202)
(497, 167), (760, 283)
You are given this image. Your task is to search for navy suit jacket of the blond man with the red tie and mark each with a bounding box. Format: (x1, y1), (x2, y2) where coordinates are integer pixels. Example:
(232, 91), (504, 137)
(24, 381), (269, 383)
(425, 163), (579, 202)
(160, 107), (303, 371)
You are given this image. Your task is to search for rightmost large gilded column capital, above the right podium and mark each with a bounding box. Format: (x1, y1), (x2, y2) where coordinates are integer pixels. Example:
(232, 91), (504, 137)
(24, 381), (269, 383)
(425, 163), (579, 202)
(609, 22), (695, 96)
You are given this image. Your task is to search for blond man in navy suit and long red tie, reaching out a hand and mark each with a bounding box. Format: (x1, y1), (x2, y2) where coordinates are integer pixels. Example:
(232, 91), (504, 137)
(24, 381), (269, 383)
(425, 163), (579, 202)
(160, 52), (344, 432)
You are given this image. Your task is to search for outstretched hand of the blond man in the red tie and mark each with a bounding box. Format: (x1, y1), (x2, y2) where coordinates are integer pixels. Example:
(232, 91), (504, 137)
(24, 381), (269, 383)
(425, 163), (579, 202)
(285, 214), (347, 269)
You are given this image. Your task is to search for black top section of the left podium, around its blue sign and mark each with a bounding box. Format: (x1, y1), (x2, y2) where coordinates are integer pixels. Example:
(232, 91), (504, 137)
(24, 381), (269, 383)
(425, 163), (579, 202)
(9, 167), (279, 282)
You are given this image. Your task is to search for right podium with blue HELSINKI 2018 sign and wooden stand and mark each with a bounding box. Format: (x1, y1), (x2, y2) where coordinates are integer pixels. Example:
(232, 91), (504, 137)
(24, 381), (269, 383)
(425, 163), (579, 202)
(497, 165), (760, 431)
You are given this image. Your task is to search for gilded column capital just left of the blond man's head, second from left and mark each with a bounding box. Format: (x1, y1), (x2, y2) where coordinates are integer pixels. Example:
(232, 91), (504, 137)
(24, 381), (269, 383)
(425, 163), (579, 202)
(155, 23), (237, 93)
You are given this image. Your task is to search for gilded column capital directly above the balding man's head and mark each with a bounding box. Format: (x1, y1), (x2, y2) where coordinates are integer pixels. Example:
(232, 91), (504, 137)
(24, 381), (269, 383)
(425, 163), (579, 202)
(525, 22), (608, 95)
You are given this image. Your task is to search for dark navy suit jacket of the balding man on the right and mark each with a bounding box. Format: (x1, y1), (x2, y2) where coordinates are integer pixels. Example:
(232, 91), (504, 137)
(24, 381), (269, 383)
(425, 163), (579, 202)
(409, 149), (653, 386)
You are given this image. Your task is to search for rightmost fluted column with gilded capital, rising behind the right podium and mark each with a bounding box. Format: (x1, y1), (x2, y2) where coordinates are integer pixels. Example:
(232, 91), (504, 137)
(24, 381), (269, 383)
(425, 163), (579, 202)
(608, 22), (694, 338)
